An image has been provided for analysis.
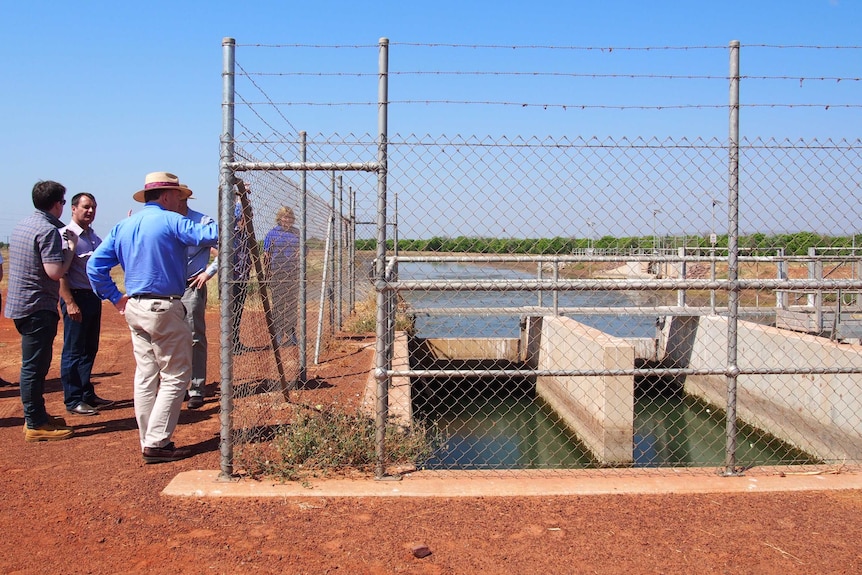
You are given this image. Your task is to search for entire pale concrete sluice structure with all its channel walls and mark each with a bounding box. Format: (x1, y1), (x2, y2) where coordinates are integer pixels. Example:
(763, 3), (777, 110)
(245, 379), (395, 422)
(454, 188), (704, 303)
(386, 316), (862, 466)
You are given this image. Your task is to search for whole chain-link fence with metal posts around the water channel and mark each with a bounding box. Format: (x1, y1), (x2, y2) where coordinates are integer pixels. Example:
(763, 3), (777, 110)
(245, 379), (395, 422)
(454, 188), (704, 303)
(222, 41), (862, 476)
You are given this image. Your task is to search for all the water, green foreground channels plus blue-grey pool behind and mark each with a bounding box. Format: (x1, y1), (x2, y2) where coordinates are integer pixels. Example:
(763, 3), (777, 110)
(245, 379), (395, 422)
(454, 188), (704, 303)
(399, 263), (811, 469)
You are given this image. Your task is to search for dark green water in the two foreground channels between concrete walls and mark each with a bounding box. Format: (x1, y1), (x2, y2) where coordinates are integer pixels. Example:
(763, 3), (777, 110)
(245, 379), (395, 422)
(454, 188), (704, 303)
(415, 382), (814, 469)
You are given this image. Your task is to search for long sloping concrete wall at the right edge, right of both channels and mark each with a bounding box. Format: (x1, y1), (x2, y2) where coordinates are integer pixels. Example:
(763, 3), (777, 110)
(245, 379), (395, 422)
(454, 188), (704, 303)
(663, 316), (862, 461)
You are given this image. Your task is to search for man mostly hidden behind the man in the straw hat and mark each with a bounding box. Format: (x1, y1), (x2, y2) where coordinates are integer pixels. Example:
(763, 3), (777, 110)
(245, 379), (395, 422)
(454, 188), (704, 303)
(180, 191), (218, 409)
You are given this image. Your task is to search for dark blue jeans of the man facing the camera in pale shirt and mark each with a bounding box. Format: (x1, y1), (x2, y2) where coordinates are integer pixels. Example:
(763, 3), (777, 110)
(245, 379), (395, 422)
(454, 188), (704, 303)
(60, 290), (102, 409)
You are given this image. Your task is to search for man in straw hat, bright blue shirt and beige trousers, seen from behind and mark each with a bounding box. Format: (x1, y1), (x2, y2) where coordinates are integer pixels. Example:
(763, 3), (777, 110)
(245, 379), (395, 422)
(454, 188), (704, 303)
(87, 172), (218, 463)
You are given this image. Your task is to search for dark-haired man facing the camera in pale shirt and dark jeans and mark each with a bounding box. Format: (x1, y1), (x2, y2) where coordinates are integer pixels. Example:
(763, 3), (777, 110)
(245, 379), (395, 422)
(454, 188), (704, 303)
(60, 192), (114, 415)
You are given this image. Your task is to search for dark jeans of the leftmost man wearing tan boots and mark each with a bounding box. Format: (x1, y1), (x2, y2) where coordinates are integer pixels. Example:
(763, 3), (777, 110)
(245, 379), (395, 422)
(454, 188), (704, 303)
(14, 310), (60, 429)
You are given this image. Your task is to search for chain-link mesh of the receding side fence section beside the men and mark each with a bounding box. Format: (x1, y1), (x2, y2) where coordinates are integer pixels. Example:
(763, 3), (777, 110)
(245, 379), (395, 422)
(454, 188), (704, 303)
(223, 140), (378, 470)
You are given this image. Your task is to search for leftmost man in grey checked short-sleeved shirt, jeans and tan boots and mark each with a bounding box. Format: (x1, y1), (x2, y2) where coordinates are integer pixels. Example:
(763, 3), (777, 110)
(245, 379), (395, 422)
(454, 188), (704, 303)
(6, 180), (78, 441)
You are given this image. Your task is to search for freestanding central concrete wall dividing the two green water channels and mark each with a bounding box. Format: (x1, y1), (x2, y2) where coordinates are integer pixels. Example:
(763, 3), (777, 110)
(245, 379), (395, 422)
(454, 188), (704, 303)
(528, 316), (635, 465)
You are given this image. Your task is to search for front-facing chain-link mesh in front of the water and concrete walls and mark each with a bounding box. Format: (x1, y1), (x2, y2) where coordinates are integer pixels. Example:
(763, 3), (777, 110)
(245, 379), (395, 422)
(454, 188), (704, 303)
(382, 134), (862, 469)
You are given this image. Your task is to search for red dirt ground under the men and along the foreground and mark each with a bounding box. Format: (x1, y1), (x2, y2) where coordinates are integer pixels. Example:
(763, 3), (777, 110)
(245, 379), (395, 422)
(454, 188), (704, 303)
(0, 306), (862, 575)
